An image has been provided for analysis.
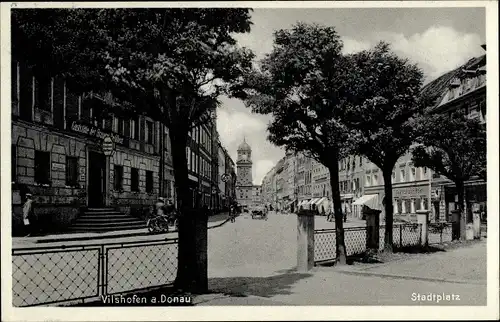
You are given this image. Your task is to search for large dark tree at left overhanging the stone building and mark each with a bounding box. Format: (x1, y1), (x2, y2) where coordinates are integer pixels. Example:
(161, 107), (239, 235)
(13, 8), (253, 292)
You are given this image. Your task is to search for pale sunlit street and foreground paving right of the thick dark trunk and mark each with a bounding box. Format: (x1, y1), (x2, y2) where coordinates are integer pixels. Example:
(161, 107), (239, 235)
(203, 215), (486, 305)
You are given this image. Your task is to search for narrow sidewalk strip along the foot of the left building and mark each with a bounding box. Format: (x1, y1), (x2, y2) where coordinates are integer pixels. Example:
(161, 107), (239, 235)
(12, 213), (229, 248)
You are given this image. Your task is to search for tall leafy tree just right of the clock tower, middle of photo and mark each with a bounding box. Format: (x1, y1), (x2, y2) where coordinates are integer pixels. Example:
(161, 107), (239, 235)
(234, 23), (354, 264)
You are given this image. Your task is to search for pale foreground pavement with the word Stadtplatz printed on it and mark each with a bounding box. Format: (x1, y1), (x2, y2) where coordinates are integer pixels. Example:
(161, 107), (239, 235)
(195, 241), (486, 305)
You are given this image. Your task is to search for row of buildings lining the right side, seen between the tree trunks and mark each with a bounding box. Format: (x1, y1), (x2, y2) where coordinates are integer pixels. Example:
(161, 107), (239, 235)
(263, 45), (486, 221)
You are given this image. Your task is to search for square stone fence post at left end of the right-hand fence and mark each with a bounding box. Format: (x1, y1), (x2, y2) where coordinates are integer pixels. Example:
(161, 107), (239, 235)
(297, 210), (314, 272)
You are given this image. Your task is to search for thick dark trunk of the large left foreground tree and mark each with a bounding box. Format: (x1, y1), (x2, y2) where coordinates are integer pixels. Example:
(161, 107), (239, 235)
(170, 128), (208, 293)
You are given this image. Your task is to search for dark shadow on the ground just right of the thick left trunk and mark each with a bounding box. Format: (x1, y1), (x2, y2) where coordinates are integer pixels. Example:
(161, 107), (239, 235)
(208, 273), (312, 297)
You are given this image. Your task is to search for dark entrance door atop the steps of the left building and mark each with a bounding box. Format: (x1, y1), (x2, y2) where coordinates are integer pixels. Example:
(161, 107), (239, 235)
(87, 151), (106, 207)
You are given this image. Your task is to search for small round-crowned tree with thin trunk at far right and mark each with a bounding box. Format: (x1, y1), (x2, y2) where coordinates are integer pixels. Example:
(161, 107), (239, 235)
(412, 111), (486, 239)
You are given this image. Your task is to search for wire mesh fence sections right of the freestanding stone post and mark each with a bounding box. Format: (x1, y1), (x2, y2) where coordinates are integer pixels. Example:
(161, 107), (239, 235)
(314, 223), (421, 263)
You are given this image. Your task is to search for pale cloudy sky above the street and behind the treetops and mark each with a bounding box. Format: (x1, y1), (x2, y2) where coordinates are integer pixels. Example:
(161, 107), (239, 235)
(217, 8), (486, 185)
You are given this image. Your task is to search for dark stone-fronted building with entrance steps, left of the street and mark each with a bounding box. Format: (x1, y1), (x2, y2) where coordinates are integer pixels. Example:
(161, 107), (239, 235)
(11, 57), (230, 234)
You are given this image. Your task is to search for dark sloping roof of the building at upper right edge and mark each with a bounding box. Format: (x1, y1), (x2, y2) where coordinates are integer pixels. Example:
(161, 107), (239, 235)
(421, 55), (486, 110)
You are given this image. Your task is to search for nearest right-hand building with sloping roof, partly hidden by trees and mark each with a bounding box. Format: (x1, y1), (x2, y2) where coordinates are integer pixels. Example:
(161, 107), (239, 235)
(363, 46), (486, 221)
